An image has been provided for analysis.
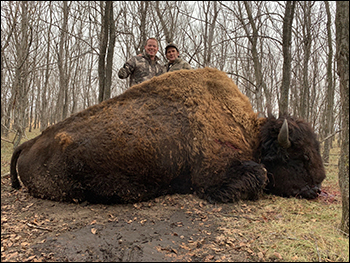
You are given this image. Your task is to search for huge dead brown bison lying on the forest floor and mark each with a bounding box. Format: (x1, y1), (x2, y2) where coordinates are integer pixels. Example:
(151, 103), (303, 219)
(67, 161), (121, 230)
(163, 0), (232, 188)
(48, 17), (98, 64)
(11, 68), (325, 203)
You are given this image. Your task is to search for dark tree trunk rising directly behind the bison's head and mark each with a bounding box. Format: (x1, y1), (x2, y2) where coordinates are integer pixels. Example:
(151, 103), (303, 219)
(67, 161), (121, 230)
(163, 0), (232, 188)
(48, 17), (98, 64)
(279, 1), (295, 116)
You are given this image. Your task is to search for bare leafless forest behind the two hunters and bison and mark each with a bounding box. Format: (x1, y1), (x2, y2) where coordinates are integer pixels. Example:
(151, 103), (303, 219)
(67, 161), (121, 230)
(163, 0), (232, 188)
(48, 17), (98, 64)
(1, 1), (349, 235)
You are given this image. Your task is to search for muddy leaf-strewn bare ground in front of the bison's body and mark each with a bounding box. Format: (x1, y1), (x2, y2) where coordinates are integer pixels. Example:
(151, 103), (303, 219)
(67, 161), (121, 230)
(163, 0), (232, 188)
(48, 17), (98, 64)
(1, 176), (253, 262)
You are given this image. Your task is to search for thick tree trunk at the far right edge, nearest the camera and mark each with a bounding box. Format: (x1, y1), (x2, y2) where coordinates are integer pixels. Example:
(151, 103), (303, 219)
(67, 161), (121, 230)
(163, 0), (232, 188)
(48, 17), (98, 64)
(335, 1), (349, 234)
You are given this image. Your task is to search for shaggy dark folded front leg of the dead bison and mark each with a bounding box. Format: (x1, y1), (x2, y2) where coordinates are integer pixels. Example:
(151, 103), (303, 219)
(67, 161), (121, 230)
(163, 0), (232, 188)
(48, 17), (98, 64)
(198, 161), (267, 203)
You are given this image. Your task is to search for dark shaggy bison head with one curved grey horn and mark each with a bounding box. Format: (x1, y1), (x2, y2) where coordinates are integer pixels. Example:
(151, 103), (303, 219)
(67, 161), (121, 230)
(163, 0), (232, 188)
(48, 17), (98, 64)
(260, 115), (326, 199)
